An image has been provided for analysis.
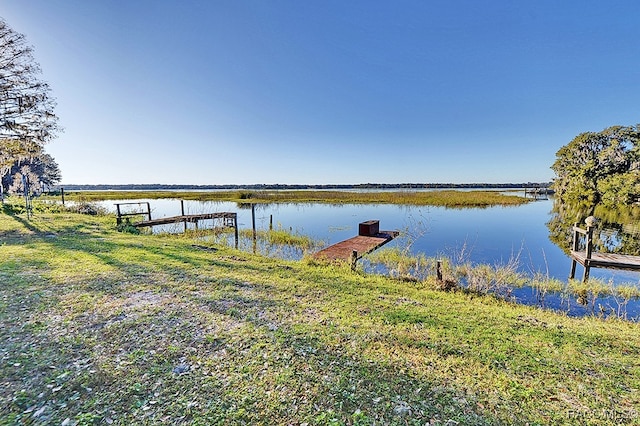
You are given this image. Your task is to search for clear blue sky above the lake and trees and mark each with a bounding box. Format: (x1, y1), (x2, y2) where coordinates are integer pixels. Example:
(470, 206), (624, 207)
(0, 0), (640, 184)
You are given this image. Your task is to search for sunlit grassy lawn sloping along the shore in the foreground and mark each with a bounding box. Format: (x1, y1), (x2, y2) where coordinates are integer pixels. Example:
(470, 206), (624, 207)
(0, 208), (640, 425)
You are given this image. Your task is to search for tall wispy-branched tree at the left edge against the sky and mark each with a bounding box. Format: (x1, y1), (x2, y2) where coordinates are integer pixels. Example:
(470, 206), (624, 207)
(0, 18), (60, 201)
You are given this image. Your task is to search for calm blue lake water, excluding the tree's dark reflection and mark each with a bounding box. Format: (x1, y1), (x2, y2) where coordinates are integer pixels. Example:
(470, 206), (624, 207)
(102, 199), (640, 317)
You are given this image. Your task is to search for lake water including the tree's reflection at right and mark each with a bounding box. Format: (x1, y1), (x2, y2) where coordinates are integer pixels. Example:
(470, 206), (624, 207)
(99, 198), (640, 317)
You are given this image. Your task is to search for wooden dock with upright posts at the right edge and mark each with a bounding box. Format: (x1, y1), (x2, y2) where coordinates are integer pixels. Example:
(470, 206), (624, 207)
(569, 216), (640, 282)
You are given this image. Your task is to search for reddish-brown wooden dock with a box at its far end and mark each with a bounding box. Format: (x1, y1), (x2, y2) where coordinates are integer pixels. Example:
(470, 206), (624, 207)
(313, 220), (399, 265)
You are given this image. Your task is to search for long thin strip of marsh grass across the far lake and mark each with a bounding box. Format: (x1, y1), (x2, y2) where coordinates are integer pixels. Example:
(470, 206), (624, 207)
(46, 191), (532, 208)
